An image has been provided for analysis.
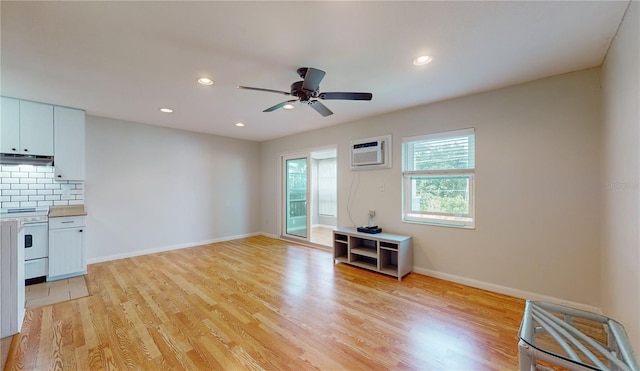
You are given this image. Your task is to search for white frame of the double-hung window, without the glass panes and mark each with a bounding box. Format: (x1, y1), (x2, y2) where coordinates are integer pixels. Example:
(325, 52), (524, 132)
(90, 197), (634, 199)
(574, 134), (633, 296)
(402, 128), (476, 229)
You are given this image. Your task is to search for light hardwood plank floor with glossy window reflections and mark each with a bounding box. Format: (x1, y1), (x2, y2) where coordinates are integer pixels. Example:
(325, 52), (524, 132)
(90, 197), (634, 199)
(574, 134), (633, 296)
(7, 236), (524, 370)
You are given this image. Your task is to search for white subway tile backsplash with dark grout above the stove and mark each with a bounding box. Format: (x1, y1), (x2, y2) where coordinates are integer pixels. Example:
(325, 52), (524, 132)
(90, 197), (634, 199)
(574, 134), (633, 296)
(0, 165), (84, 209)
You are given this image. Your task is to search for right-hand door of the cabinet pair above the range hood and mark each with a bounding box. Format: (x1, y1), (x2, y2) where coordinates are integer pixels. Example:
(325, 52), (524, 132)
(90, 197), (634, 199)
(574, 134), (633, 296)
(20, 101), (53, 156)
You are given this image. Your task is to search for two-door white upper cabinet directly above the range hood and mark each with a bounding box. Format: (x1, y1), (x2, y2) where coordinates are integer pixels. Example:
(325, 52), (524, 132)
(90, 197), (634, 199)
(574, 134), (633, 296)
(0, 97), (53, 156)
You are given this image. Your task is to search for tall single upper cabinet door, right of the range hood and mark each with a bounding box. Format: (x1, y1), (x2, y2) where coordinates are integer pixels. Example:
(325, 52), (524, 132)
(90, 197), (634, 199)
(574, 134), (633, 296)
(53, 107), (85, 180)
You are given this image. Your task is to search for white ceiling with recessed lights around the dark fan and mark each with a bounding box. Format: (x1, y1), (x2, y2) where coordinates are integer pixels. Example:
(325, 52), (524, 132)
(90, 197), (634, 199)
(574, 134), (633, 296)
(0, 0), (628, 141)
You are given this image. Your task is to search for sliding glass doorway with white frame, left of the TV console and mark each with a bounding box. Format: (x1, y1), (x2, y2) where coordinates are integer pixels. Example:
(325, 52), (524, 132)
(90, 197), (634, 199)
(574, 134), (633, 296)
(282, 147), (338, 248)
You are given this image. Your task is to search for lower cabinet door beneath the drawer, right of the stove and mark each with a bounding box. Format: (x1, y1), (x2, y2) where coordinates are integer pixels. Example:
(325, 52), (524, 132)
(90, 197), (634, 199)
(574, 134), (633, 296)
(49, 227), (87, 277)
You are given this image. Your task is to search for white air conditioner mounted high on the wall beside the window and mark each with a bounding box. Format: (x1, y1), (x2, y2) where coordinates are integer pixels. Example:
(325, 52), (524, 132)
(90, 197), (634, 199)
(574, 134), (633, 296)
(351, 135), (391, 170)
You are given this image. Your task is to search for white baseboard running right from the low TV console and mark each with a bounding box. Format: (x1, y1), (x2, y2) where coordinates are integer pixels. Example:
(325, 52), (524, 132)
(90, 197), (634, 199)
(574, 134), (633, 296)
(413, 267), (603, 314)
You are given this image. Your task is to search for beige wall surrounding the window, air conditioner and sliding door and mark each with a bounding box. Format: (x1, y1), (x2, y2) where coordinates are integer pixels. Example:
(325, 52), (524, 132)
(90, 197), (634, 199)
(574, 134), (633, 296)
(261, 69), (601, 306)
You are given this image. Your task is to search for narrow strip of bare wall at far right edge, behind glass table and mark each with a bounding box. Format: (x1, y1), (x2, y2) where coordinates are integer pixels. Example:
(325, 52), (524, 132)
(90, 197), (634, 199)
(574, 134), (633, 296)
(601, 1), (640, 356)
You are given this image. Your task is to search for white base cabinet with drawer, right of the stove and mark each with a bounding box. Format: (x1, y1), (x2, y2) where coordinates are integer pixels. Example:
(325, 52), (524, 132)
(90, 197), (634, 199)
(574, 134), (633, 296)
(47, 216), (87, 281)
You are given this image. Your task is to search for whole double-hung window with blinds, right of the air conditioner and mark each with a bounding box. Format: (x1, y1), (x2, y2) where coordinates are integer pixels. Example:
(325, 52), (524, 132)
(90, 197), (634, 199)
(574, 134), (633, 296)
(402, 128), (475, 228)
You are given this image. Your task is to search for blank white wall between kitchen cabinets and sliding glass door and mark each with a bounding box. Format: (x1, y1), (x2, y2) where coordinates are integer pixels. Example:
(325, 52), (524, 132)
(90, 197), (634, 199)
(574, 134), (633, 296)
(85, 116), (260, 262)
